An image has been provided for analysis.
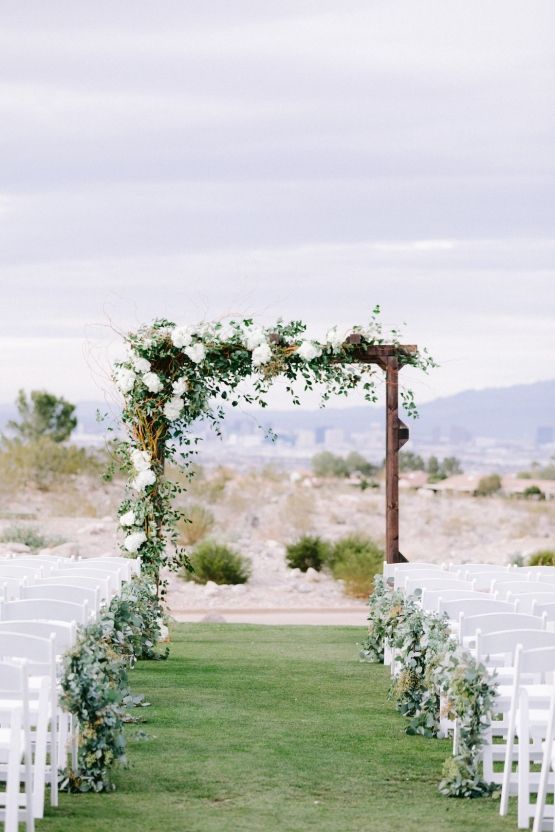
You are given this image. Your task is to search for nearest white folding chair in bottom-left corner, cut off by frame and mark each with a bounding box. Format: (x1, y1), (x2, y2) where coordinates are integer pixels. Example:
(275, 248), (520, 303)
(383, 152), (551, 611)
(0, 661), (35, 832)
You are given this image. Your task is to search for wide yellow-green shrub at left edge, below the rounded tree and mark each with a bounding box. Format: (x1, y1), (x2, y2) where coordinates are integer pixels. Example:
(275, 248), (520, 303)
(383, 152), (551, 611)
(0, 436), (103, 491)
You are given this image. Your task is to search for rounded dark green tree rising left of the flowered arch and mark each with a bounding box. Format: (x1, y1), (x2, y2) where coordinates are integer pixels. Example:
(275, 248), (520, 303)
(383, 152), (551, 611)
(8, 390), (77, 442)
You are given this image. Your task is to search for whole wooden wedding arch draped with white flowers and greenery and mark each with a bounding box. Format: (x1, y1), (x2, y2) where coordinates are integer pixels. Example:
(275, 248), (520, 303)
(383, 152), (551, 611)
(114, 307), (434, 588)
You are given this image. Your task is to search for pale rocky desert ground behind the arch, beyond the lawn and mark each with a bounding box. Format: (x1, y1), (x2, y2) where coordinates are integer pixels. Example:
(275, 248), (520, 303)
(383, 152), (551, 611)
(0, 469), (555, 613)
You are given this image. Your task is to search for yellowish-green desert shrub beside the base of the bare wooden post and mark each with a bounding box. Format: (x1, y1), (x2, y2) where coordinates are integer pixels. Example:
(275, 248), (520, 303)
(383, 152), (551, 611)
(329, 534), (384, 598)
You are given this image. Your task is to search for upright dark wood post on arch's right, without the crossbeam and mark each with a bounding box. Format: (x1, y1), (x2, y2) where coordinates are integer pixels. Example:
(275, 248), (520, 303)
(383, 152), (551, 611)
(385, 355), (406, 563)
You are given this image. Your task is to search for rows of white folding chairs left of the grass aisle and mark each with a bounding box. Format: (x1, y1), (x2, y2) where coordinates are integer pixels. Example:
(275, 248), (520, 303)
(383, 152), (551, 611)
(0, 557), (138, 832)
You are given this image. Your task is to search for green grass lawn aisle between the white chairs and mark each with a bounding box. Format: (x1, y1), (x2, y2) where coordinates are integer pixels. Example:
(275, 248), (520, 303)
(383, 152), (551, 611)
(37, 624), (516, 832)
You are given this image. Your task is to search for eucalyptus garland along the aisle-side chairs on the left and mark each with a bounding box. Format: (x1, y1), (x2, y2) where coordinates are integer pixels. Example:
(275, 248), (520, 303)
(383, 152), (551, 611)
(61, 577), (163, 792)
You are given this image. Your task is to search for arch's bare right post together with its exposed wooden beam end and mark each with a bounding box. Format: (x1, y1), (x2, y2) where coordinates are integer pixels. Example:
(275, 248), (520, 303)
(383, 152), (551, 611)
(347, 334), (417, 563)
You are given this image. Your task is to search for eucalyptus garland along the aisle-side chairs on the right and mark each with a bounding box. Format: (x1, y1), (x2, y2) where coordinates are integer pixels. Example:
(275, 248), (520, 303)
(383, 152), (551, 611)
(361, 578), (496, 797)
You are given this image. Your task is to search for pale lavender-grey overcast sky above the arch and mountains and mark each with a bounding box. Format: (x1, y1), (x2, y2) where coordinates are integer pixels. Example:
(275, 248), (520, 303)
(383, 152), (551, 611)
(0, 0), (555, 412)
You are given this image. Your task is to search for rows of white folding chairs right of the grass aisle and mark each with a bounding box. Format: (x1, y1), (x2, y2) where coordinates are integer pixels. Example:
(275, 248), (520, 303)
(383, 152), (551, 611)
(384, 564), (555, 832)
